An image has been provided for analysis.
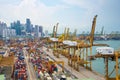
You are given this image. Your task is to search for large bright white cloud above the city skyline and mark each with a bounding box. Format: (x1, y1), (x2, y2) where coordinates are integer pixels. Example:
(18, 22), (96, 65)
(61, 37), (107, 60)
(0, 0), (66, 28)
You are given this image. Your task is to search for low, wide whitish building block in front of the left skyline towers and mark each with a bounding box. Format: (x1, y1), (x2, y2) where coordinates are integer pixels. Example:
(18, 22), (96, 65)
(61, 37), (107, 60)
(2, 29), (16, 38)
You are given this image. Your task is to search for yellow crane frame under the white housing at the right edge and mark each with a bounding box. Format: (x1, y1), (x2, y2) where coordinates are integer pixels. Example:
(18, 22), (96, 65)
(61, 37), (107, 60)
(90, 48), (120, 80)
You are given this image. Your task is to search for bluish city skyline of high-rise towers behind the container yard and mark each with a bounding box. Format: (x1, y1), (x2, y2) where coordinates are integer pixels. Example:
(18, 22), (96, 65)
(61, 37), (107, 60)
(0, 18), (44, 38)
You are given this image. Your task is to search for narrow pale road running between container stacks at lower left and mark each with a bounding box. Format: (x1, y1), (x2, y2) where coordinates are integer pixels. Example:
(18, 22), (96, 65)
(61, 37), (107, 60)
(23, 49), (37, 80)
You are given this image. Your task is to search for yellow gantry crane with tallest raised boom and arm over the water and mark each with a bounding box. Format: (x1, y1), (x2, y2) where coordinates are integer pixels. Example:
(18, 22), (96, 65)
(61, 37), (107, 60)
(63, 15), (108, 70)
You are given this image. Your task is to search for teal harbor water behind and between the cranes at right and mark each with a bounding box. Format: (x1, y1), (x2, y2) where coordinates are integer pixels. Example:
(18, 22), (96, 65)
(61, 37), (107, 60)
(92, 40), (120, 77)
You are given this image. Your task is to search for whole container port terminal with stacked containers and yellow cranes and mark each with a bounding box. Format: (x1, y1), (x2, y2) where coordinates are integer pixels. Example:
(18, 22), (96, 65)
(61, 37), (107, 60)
(0, 15), (120, 80)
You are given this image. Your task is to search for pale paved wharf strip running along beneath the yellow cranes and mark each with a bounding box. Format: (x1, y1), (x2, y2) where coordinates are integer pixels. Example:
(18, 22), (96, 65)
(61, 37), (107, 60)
(43, 47), (105, 80)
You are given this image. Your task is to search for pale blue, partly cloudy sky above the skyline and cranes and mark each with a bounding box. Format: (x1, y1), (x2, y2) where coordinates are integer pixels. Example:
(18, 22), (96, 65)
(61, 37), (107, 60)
(0, 0), (120, 33)
